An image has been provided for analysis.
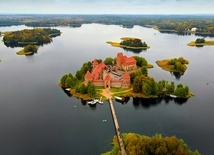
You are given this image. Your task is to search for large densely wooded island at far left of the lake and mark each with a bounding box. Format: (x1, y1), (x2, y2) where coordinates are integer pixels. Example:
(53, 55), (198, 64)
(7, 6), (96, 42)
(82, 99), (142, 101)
(3, 28), (61, 47)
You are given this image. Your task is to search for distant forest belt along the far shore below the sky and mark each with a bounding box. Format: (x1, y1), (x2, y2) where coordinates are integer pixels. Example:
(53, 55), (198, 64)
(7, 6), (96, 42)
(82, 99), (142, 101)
(0, 15), (214, 36)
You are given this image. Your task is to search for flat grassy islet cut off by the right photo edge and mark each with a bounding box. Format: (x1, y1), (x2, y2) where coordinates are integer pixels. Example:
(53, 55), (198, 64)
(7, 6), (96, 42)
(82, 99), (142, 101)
(187, 38), (214, 47)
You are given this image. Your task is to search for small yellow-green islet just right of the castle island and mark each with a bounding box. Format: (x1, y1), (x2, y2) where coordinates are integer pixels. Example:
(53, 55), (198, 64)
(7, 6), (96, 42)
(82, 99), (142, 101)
(156, 57), (189, 74)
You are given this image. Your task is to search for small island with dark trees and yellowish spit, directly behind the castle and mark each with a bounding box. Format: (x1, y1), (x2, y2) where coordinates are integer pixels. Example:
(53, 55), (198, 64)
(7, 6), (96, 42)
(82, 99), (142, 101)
(107, 37), (150, 51)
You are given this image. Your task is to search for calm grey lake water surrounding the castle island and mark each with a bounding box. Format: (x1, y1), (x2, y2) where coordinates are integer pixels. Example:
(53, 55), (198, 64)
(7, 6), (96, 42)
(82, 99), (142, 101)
(0, 24), (214, 155)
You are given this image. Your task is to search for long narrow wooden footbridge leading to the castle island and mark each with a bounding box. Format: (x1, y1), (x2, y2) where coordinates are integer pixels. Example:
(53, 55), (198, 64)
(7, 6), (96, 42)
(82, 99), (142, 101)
(106, 89), (126, 155)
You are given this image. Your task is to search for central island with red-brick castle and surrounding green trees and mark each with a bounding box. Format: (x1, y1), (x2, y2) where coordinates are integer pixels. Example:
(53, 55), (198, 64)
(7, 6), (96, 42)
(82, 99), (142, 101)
(59, 52), (194, 100)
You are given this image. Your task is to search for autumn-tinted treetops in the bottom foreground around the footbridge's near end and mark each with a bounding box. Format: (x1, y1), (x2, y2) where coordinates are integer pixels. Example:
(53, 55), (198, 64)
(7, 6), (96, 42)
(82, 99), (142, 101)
(101, 133), (200, 155)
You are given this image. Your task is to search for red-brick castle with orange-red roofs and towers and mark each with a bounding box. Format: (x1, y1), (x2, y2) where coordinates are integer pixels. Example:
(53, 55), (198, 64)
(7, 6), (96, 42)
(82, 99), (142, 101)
(84, 53), (137, 88)
